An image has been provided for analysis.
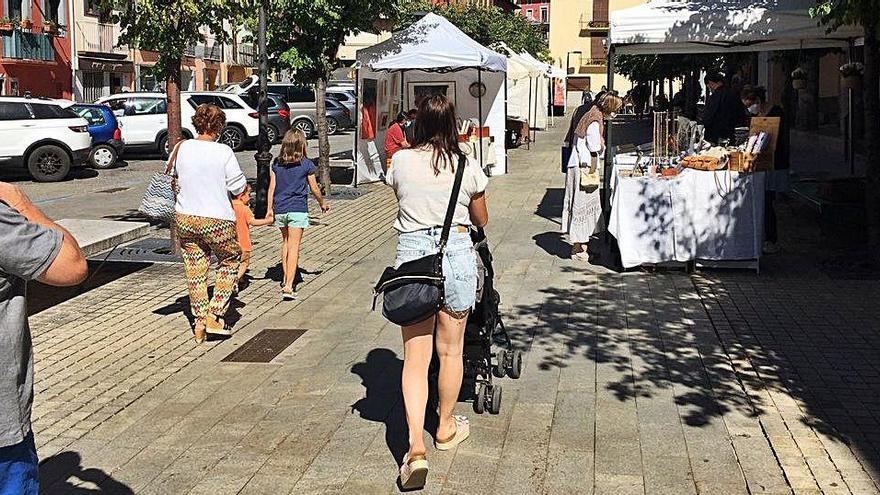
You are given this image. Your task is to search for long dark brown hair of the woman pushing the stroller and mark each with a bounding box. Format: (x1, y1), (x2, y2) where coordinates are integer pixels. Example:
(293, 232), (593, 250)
(412, 95), (464, 175)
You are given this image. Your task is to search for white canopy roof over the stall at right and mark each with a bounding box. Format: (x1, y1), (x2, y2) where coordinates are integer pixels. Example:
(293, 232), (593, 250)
(611, 0), (861, 54)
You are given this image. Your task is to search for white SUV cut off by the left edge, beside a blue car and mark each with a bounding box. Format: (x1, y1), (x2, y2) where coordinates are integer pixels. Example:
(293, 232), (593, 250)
(0, 97), (92, 182)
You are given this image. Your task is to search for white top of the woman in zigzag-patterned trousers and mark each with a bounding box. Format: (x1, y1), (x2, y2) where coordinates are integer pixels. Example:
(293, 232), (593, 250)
(174, 139), (247, 221)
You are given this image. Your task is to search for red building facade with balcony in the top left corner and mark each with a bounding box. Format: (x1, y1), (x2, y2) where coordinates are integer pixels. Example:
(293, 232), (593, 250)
(0, 0), (75, 98)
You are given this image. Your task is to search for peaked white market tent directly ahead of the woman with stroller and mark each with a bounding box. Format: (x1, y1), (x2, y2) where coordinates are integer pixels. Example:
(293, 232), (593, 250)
(354, 13), (507, 183)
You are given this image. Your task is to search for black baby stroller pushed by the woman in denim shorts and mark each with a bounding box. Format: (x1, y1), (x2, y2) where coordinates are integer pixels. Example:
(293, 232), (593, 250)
(462, 229), (522, 414)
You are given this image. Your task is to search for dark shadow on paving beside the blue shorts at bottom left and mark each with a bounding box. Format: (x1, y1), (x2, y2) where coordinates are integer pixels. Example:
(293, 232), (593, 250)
(40, 451), (134, 495)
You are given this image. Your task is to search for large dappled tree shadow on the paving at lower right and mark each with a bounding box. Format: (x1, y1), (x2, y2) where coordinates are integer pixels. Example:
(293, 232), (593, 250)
(524, 180), (880, 484)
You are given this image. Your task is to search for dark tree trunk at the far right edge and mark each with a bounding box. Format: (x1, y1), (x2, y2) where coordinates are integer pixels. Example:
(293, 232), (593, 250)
(863, 20), (880, 252)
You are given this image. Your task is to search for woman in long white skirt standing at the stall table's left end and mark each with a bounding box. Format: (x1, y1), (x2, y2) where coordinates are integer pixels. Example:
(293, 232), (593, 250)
(562, 93), (623, 261)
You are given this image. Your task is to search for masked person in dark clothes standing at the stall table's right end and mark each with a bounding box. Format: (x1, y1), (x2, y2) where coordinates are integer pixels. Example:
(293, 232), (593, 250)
(742, 87), (791, 254)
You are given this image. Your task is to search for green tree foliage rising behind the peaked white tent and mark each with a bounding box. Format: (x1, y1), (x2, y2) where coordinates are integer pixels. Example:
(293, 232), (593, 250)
(396, 0), (552, 61)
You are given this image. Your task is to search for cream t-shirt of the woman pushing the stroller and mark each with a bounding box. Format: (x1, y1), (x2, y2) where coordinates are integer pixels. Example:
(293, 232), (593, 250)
(385, 149), (489, 232)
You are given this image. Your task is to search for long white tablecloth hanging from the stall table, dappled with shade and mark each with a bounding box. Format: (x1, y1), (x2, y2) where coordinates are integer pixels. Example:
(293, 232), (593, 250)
(609, 169), (764, 268)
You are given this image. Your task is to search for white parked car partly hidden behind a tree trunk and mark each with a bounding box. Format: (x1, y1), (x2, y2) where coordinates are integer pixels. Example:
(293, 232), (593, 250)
(96, 91), (259, 154)
